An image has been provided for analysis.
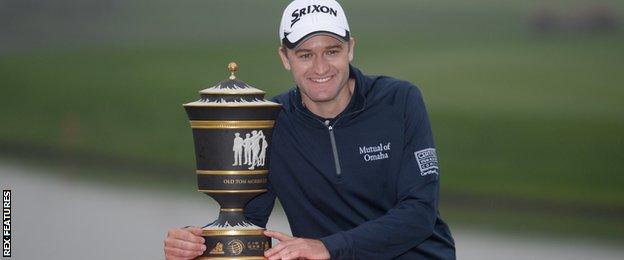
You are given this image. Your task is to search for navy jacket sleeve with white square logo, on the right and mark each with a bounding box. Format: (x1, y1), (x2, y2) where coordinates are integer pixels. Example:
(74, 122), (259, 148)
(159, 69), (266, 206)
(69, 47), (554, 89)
(321, 84), (439, 259)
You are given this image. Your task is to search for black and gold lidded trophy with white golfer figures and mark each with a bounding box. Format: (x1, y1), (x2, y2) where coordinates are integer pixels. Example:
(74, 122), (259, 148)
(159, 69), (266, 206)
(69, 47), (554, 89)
(184, 62), (281, 259)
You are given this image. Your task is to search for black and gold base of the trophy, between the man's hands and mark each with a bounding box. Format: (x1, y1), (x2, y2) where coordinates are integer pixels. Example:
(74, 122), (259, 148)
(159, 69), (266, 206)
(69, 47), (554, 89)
(196, 227), (271, 260)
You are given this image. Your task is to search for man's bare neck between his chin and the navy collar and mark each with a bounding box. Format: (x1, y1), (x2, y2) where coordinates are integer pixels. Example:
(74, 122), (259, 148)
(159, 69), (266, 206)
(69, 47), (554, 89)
(301, 79), (355, 118)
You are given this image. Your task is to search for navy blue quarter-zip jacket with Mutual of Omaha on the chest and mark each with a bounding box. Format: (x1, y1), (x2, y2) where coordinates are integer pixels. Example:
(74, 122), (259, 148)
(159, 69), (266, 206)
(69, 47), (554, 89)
(245, 67), (455, 259)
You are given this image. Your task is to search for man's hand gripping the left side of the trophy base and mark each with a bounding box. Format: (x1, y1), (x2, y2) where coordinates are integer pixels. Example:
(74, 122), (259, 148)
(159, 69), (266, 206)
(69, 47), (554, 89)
(165, 227), (206, 260)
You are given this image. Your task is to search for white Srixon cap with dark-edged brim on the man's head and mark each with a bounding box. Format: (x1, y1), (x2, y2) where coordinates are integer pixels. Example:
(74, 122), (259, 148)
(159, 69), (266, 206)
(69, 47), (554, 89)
(279, 0), (349, 49)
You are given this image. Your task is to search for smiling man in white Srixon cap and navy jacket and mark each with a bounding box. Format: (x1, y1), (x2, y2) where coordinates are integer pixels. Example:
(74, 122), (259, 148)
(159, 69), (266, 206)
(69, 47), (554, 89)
(165, 0), (455, 259)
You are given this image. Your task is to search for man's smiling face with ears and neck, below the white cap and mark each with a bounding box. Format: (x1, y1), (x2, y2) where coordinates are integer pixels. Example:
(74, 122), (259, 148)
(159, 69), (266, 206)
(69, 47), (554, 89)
(279, 35), (355, 116)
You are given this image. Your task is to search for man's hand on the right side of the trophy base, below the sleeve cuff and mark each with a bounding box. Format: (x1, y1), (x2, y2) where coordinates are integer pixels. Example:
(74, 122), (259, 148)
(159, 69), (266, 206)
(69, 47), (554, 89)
(264, 230), (330, 259)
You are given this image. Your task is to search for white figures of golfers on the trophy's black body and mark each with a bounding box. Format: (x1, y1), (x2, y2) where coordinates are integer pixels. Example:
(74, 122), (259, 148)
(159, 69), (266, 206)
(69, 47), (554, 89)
(232, 130), (269, 170)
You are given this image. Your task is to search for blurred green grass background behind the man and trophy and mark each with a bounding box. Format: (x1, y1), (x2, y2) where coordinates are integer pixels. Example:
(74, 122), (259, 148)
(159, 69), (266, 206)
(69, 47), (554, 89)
(0, 0), (624, 244)
